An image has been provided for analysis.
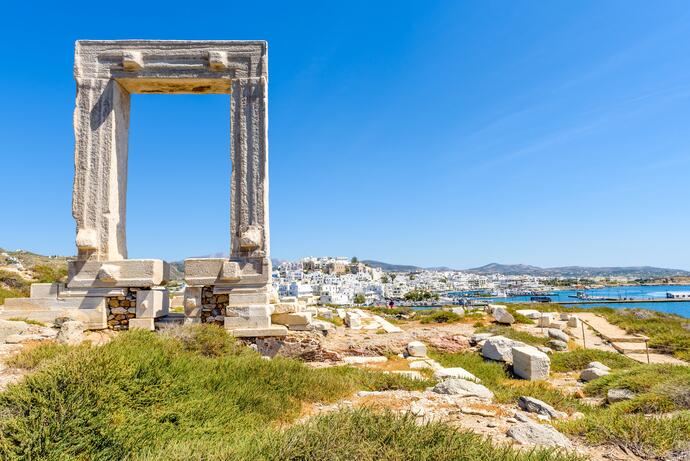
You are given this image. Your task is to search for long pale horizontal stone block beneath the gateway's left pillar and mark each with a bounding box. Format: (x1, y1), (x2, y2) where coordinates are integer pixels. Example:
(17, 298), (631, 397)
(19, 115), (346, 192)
(67, 259), (170, 288)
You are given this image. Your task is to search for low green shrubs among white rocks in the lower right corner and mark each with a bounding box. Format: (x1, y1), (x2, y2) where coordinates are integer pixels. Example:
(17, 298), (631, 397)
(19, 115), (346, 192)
(430, 351), (690, 457)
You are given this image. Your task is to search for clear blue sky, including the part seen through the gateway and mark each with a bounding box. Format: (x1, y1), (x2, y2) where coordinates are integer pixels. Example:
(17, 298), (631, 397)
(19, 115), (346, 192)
(0, 0), (690, 269)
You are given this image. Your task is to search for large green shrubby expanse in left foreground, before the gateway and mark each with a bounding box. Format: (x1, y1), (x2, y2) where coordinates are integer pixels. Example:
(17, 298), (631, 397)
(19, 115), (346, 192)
(0, 325), (576, 461)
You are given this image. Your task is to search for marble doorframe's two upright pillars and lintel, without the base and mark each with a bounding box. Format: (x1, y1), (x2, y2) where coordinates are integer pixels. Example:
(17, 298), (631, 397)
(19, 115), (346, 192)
(72, 40), (270, 262)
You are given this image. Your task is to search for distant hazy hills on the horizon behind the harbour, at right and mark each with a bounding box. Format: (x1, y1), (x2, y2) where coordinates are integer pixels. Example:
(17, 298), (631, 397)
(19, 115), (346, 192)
(464, 263), (690, 278)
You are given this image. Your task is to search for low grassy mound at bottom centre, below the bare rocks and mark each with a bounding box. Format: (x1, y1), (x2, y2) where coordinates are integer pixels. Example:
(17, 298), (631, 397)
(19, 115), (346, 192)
(250, 410), (581, 461)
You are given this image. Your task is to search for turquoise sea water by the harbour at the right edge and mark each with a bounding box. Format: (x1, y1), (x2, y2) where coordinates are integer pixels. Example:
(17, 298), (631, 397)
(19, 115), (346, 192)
(456, 285), (690, 317)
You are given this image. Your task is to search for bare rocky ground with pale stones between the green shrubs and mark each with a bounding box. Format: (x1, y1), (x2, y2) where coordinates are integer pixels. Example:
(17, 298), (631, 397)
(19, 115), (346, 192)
(0, 306), (684, 460)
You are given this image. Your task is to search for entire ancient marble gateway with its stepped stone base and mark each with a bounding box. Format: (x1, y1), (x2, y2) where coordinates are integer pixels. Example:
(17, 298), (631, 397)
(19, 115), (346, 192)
(2, 40), (300, 337)
